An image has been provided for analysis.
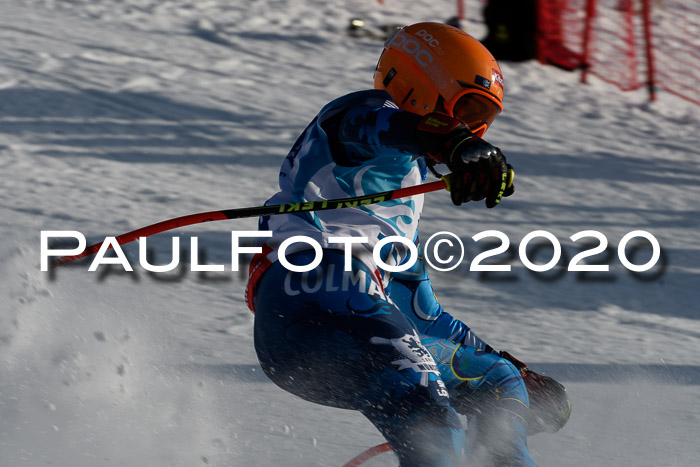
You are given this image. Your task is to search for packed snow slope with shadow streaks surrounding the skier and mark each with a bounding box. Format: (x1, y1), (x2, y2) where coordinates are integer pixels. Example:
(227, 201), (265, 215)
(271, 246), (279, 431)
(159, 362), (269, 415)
(0, 0), (700, 467)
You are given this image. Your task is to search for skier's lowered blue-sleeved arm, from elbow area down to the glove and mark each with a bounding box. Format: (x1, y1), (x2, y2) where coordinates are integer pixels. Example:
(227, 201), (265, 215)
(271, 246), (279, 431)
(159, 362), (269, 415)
(389, 247), (497, 353)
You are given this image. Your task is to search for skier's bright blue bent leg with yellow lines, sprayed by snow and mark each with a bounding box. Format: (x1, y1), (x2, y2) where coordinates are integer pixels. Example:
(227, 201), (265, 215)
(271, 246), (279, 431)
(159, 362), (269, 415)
(422, 338), (535, 466)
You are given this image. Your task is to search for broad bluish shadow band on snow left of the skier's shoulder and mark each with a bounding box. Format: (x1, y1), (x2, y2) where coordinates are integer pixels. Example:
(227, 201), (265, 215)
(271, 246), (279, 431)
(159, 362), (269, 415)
(0, 88), (291, 167)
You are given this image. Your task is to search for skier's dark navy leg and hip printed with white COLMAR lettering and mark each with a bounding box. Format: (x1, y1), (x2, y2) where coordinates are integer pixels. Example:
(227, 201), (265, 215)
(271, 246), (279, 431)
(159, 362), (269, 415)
(255, 252), (466, 466)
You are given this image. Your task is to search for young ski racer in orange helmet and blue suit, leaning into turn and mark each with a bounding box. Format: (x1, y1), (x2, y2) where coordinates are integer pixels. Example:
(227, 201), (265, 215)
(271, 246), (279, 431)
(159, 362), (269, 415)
(246, 23), (570, 466)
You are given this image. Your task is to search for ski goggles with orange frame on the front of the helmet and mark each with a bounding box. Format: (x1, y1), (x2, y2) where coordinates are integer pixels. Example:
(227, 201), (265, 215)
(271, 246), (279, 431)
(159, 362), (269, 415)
(445, 88), (503, 138)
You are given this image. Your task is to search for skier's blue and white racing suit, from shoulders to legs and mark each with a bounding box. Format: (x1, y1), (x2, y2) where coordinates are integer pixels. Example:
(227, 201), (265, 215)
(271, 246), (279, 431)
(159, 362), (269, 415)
(246, 90), (535, 466)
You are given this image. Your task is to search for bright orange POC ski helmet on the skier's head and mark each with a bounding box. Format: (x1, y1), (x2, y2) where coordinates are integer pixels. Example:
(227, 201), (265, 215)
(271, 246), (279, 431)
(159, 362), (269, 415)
(374, 23), (503, 136)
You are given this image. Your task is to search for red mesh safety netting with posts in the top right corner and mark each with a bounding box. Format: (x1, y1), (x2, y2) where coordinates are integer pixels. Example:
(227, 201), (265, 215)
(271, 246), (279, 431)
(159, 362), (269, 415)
(537, 0), (700, 104)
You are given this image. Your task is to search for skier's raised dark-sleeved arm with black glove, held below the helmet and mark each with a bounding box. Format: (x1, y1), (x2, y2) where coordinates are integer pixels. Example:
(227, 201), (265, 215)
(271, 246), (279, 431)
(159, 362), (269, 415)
(322, 96), (514, 208)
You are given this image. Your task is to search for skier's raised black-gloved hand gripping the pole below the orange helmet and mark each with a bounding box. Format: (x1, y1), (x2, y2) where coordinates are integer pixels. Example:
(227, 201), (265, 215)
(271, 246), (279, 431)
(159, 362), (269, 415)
(417, 113), (515, 208)
